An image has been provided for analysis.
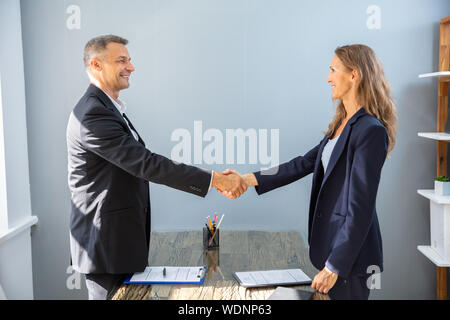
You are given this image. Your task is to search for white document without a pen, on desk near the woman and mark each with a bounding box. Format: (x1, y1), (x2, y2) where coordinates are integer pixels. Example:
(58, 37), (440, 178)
(233, 269), (312, 287)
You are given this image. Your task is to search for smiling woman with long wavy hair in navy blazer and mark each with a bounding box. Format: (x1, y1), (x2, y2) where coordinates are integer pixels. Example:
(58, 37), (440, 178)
(224, 45), (397, 299)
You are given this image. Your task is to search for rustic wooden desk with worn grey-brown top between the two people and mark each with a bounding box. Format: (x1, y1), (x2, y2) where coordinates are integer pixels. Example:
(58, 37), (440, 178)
(112, 230), (328, 300)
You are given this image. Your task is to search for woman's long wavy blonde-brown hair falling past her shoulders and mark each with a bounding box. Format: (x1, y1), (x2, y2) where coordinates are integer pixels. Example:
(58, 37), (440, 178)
(325, 44), (397, 154)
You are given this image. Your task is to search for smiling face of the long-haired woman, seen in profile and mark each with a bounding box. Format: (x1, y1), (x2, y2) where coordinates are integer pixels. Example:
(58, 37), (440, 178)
(327, 55), (355, 100)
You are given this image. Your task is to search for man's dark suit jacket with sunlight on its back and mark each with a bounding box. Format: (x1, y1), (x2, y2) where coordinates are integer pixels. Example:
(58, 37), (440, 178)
(67, 85), (211, 273)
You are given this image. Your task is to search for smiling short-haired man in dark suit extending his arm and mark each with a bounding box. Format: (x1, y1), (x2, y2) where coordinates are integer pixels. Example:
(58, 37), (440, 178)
(67, 35), (247, 299)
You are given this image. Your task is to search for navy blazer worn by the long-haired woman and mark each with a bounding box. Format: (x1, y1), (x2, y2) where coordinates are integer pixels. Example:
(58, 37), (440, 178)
(255, 108), (389, 278)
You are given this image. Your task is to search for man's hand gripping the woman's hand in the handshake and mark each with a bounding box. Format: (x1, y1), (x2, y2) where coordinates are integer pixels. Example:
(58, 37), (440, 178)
(212, 170), (248, 199)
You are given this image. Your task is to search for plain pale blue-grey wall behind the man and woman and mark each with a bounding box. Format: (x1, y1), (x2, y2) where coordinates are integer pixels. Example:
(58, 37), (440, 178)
(21, 0), (450, 299)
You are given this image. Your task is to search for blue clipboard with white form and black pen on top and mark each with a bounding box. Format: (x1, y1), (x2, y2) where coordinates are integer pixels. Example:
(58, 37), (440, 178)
(125, 266), (206, 284)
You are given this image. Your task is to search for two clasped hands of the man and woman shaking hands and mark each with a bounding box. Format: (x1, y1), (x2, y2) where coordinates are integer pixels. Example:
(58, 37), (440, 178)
(212, 169), (258, 199)
